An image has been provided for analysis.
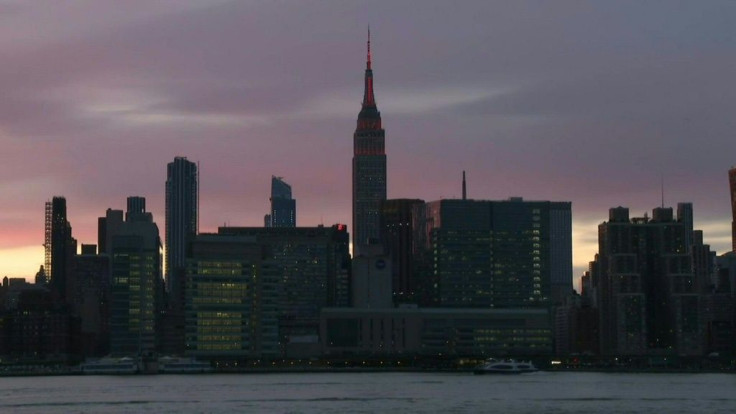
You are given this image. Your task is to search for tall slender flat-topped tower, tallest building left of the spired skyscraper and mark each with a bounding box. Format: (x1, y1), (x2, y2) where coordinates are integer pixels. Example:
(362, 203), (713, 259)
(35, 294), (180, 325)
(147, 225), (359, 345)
(165, 157), (199, 300)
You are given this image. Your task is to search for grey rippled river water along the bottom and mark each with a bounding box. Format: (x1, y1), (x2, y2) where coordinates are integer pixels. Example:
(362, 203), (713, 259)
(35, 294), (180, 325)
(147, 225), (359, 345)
(0, 372), (736, 414)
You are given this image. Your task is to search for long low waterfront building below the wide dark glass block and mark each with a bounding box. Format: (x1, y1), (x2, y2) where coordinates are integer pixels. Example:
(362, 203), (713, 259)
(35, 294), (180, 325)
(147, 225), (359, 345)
(321, 307), (553, 358)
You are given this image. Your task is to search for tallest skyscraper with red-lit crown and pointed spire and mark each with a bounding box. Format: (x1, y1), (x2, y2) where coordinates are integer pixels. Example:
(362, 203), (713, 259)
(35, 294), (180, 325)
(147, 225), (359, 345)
(353, 31), (386, 256)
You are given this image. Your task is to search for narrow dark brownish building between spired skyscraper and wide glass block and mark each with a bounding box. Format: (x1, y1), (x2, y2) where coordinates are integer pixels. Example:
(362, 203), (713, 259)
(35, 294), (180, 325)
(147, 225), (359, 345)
(380, 198), (424, 304)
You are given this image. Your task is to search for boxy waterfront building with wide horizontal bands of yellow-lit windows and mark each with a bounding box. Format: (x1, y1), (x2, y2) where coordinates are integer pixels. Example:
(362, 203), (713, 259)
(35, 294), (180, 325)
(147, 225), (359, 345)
(185, 234), (281, 361)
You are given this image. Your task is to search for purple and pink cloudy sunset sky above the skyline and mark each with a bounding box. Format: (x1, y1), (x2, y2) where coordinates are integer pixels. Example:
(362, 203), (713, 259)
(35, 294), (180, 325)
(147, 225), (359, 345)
(0, 0), (736, 290)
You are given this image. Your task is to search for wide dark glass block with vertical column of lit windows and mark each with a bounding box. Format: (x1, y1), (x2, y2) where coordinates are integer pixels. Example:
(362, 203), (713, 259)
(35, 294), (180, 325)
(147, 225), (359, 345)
(413, 198), (572, 308)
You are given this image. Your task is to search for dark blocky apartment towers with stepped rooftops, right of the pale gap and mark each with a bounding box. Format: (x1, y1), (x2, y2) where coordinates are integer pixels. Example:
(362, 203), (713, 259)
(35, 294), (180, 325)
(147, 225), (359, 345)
(591, 207), (712, 356)
